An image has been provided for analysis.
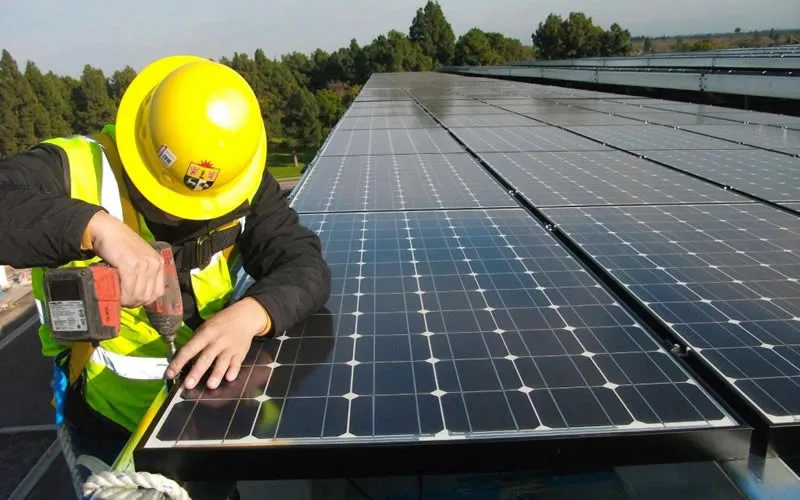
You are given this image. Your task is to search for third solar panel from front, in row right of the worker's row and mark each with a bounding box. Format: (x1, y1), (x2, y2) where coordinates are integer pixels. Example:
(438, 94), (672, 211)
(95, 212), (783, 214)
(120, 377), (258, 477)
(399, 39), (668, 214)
(453, 127), (609, 153)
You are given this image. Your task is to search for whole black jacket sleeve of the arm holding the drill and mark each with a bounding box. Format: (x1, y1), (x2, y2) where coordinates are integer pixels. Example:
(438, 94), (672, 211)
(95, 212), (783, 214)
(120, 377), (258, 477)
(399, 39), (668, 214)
(0, 144), (103, 269)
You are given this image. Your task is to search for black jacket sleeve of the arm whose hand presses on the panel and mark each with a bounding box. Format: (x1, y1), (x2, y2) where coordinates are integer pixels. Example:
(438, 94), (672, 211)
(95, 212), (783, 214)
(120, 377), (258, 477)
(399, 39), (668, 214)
(234, 171), (331, 335)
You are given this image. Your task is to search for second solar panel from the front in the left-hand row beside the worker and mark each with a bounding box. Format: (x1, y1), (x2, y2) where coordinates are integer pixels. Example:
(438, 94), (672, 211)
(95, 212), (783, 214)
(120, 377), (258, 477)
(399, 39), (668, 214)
(292, 153), (518, 212)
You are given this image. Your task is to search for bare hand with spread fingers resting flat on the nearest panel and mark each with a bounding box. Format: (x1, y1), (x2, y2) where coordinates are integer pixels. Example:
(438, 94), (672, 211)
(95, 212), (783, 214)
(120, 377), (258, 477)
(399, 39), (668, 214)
(167, 297), (268, 389)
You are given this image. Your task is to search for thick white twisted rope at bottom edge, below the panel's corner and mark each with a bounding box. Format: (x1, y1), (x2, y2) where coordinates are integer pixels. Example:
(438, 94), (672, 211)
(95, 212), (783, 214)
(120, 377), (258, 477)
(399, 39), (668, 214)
(83, 471), (191, 500)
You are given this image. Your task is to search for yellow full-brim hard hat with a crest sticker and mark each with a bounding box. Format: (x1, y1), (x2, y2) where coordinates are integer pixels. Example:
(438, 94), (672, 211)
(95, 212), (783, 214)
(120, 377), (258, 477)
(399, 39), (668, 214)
(116, 56), (267, 220)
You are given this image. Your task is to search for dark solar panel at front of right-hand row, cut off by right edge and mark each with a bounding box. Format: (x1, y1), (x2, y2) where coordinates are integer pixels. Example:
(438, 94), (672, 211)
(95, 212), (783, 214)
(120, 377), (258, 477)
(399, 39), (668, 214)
(545, 204), (800, 424)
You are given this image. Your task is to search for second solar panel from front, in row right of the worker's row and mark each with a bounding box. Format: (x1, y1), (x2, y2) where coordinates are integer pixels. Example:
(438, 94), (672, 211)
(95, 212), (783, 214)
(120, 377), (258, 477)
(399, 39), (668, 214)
(481, 151), (747, 207)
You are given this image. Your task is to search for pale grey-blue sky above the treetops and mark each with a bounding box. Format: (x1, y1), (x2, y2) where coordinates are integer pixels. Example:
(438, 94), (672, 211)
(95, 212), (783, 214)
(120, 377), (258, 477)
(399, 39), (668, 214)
(0, 0), (800, 75)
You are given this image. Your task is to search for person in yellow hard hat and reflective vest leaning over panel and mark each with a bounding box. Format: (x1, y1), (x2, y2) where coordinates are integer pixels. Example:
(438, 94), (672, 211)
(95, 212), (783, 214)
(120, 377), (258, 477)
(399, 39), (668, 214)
(0, 56), (331, 496)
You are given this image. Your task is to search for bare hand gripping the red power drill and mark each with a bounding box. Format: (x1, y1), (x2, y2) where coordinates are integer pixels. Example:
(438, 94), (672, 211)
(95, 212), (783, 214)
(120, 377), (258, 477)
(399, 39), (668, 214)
(87, 212), (164, 307)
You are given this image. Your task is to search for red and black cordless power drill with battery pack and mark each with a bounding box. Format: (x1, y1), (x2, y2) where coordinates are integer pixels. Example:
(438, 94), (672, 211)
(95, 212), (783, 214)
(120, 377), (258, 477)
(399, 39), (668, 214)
(44, 241), (183, 362)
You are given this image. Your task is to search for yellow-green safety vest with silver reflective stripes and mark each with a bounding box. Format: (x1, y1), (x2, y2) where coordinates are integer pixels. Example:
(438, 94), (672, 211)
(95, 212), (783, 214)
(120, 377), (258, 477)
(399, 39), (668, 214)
(31, 125), (250, 432)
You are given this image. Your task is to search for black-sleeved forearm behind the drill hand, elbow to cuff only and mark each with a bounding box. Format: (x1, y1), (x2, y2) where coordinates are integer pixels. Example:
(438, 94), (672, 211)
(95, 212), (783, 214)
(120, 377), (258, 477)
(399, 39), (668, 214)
(0, 184), (102, 268)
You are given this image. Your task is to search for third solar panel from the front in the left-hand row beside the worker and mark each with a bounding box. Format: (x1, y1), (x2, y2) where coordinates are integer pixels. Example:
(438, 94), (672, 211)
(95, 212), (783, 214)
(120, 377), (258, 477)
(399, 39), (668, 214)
(323, 127), (464, 156)
